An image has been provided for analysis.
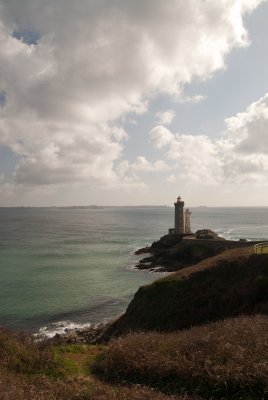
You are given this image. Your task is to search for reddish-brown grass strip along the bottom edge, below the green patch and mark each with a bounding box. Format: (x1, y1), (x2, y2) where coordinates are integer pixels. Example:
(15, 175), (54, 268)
(0, 371), (199, 400)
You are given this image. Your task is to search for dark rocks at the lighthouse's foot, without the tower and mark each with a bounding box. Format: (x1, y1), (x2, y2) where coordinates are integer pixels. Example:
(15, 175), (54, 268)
(135, 229), (224, 272)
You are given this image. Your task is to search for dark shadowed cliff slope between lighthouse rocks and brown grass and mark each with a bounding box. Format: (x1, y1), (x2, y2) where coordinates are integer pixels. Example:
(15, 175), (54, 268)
(102, 248), (268, 340)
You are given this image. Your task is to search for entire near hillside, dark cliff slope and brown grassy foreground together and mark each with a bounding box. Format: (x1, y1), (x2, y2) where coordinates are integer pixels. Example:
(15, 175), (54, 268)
(0, 249), (268, 400)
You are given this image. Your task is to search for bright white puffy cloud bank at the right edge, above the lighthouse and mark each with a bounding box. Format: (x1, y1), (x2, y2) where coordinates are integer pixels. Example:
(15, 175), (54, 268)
(150, 93), (268, 184)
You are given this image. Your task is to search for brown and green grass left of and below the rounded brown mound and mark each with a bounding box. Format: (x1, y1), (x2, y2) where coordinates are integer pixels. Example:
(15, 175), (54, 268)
(0, 329), (195, 400)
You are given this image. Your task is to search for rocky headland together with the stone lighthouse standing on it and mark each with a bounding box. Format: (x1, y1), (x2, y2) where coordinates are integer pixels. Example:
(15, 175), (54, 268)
(136, 196), (260, 272)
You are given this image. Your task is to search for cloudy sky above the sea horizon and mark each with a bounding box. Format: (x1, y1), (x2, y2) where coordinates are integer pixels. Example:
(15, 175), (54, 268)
(0, 0), (268, 206)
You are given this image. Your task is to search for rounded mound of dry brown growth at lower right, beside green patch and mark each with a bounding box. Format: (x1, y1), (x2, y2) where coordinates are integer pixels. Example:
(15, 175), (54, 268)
(94, 316), (268, 399)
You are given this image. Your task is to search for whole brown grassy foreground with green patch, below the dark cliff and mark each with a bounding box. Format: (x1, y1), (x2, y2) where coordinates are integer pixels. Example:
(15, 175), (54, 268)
(0, 316), (268, 400)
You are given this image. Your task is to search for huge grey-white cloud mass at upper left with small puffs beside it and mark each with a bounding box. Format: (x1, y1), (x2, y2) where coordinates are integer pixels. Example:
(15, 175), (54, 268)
(0, 0), (262, 191)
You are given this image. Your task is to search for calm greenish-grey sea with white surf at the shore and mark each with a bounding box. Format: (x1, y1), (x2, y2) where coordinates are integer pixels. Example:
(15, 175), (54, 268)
(0, 206), (268, 337)
